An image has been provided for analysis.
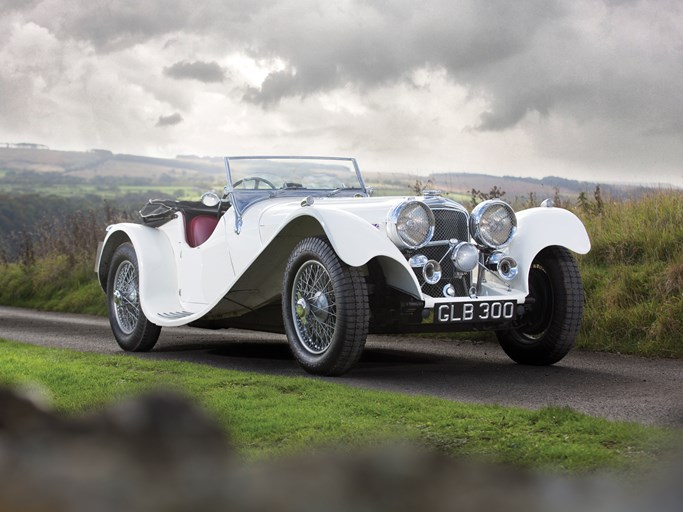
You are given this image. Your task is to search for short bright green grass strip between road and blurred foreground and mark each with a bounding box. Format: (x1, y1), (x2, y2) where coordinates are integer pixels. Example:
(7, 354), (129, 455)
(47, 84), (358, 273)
(0, 339), (677, 471)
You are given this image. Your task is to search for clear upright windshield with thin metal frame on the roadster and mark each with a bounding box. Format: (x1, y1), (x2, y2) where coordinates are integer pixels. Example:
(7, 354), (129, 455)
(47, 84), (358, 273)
(225, 157), (365, 193)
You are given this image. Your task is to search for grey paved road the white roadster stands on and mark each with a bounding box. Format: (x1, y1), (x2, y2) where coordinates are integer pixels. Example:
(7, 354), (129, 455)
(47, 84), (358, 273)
(0, 307), (683, 427)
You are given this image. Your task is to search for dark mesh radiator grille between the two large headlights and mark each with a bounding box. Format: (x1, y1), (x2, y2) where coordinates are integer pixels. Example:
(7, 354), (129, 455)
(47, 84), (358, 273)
(408, 207), (471, 297)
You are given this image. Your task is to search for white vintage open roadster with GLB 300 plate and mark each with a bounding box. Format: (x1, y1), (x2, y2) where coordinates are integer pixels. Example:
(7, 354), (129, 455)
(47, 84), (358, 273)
(96, 157), (590, 375)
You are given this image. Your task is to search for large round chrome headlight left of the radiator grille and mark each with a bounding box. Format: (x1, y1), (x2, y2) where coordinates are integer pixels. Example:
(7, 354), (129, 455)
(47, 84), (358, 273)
(387, 200), (434, 249)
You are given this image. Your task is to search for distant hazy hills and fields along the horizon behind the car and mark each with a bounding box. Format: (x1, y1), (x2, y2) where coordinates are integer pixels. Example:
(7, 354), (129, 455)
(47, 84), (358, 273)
(0, 148), (664, 203)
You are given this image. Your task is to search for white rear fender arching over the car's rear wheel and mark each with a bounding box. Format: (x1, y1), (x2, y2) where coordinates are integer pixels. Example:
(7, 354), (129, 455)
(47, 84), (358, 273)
(97, 223), (182, 321)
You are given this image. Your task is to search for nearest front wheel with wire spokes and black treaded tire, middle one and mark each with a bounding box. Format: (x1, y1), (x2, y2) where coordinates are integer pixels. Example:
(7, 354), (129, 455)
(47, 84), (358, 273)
(282, 237), (370, 376)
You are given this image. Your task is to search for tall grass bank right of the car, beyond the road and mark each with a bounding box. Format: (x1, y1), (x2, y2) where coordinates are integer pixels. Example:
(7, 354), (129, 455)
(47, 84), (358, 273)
(578, 192), (683, 358)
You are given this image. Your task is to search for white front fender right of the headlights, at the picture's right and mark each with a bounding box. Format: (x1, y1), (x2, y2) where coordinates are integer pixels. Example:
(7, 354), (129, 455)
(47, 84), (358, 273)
(508, 208), (591, 294)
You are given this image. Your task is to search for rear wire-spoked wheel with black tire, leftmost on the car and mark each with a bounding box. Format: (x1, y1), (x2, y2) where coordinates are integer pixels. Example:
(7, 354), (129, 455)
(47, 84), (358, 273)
(107, 243), (161, 352)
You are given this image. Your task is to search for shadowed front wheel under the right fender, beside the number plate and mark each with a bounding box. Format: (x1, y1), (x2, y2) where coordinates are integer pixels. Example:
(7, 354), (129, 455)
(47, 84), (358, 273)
(496, 246), (583, 366)
